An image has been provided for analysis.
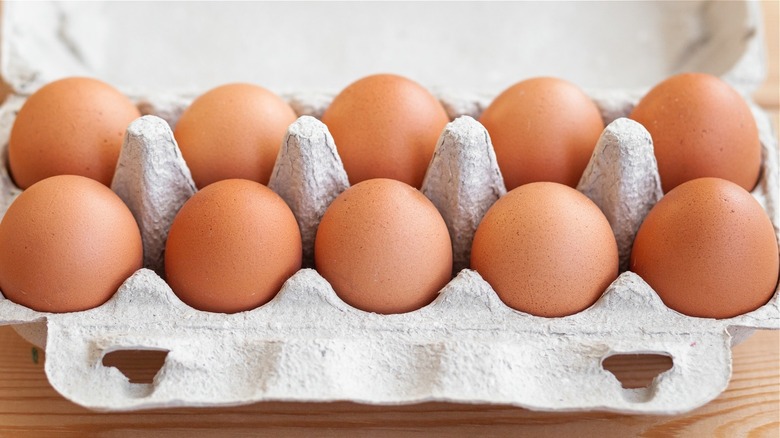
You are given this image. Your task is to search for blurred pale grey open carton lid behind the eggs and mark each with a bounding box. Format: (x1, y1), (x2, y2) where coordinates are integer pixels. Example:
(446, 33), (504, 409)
(0, 1), (765, 95)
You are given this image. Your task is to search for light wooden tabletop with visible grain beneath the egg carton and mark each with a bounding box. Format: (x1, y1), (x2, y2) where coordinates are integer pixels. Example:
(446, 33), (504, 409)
(0, 1), (780, 438)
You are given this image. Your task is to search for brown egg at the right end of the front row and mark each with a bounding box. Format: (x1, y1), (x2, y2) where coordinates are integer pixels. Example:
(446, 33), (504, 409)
(631, 178), (780, 318)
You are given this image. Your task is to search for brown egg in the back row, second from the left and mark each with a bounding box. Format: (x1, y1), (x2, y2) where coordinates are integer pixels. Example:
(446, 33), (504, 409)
(174, 84), (297, 188)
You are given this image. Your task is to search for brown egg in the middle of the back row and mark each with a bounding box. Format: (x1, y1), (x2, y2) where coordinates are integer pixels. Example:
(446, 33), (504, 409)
(322, 74), (449, 188)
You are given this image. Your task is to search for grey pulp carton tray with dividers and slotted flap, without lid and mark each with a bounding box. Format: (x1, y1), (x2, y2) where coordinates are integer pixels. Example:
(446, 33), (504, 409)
(0, 82), (780, 414)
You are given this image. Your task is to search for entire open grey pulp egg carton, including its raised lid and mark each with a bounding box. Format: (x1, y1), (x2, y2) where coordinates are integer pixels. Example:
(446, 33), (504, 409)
(0, 1), (780, 414)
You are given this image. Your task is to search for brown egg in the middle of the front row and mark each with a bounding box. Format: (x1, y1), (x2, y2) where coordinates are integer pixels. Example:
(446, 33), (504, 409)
(314, 179), (452, 313)
